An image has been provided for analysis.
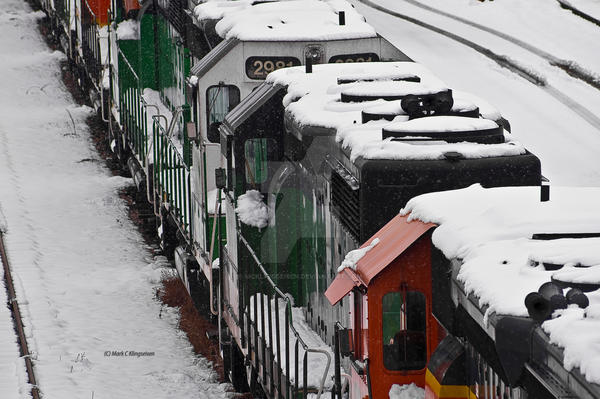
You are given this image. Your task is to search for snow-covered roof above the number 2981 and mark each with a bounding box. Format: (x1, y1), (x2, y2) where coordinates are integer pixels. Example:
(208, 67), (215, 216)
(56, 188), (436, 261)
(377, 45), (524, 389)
(194, 0), (377, 41)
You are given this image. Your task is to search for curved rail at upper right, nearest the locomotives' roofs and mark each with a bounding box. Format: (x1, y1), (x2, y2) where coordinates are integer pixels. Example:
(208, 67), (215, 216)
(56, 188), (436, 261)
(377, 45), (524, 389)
(357, 0), (600, 131)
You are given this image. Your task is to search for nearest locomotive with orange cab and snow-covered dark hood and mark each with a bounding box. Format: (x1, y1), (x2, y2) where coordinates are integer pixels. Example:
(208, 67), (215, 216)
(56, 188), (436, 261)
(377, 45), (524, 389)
(332, 185), (600, 398)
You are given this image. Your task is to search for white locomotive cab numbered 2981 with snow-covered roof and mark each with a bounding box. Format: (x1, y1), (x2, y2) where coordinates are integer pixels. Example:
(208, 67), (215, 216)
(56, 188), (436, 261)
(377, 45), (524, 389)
(184, 1), (409, 294)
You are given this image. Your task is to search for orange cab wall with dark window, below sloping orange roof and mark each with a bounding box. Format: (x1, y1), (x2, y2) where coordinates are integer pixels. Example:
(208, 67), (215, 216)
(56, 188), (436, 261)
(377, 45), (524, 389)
(368, 239), (437, 398)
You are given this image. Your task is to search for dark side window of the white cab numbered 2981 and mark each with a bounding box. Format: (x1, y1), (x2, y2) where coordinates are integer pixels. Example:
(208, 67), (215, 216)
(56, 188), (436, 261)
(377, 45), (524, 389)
(206, 85), (240, 143)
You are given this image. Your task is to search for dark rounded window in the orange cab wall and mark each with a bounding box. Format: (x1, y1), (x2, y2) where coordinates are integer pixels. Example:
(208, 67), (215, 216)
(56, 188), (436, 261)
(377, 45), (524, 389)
(382, 291), (427, 370)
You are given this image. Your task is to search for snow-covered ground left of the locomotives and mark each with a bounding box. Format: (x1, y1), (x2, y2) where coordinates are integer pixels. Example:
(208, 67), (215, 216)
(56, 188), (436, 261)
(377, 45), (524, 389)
(0, 0), (229, 399)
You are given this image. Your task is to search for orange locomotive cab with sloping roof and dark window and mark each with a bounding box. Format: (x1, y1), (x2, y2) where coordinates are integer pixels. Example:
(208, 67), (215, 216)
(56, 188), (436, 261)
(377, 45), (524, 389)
(325, 216), (445, 399)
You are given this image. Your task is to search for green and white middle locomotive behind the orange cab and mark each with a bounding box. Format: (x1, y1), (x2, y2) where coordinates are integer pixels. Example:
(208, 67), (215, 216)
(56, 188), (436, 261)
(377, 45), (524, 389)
(220, 62), (541, 398)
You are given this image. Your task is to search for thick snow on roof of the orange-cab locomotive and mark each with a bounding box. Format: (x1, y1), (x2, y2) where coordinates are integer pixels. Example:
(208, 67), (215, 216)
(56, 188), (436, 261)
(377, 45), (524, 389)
(401, 185), (600, 383)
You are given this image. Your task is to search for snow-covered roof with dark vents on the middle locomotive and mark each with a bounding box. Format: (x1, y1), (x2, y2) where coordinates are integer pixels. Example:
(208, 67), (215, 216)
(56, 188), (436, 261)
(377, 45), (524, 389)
(267, 62), (526, 160)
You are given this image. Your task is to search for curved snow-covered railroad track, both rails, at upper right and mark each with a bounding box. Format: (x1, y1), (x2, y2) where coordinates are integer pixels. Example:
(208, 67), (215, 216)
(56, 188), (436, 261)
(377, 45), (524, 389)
(356, 0), (600, 132)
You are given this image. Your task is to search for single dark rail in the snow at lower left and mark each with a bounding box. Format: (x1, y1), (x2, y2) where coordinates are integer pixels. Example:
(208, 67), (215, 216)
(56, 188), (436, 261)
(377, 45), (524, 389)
(0, 230), (40, 399)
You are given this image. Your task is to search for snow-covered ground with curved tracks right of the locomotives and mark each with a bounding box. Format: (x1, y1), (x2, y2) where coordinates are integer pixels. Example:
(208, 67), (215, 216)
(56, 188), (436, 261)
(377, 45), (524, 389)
(352, 0), (600, 186)
